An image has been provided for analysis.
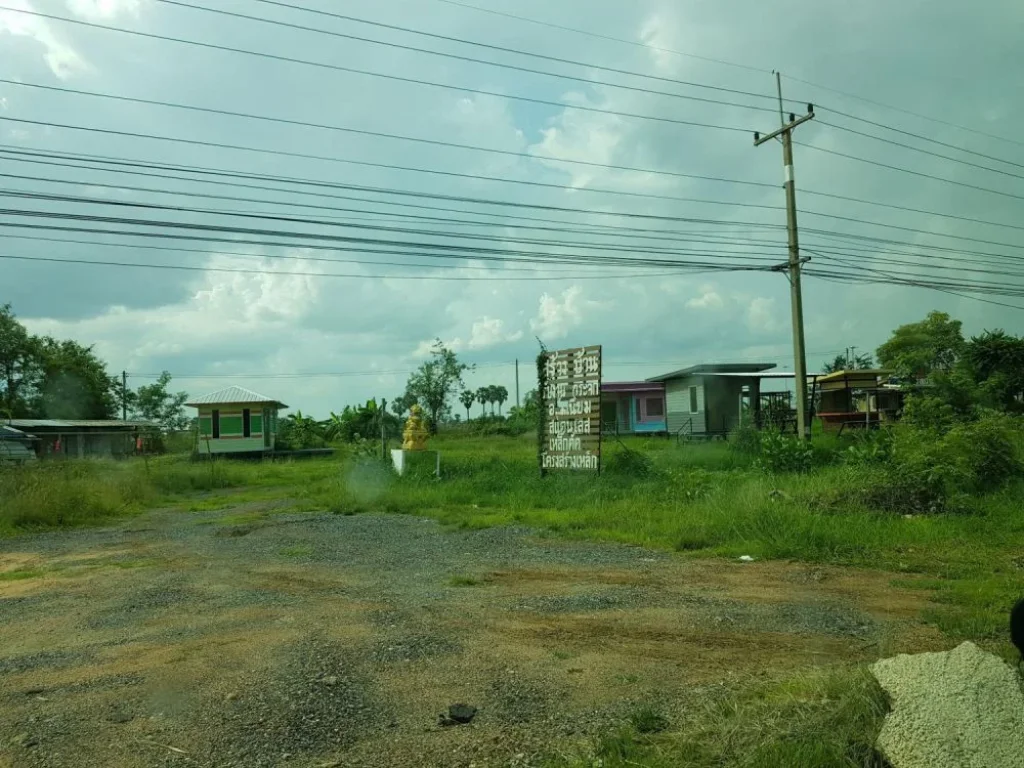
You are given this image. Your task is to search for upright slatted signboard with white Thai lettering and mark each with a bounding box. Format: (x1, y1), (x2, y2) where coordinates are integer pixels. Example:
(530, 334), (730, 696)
(541, 346), (601, 473)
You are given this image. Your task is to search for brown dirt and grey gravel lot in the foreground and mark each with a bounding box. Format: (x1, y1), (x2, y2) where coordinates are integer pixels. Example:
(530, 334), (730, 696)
(0, 506), (941, 768)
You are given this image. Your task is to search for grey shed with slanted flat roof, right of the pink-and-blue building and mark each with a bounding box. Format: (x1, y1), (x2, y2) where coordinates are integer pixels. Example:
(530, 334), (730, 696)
(647, 362), (775, 436)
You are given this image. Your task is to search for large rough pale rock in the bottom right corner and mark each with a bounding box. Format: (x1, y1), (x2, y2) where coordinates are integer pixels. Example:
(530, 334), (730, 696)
(871, 642), (1024, 768)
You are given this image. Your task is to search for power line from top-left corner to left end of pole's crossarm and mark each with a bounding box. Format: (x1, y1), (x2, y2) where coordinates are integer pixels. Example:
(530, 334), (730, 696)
(0, 6), (749, 133)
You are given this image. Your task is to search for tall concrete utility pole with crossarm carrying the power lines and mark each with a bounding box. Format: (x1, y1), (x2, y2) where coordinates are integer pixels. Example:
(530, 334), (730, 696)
(754, 72), (814, 438)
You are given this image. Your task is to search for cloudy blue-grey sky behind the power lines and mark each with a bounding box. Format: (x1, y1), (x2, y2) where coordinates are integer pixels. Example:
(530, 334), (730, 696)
(0, 0), (1024, 416)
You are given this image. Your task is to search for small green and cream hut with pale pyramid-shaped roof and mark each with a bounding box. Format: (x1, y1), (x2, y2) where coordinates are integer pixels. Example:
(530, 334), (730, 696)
(186, 387), (288, 455)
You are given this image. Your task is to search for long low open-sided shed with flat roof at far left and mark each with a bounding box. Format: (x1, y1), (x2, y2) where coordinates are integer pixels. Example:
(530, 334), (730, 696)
(4, 419), (159, 459)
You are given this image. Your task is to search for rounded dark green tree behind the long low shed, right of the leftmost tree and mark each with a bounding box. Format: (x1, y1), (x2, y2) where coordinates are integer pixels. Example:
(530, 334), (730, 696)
(34, 336), (121, 419)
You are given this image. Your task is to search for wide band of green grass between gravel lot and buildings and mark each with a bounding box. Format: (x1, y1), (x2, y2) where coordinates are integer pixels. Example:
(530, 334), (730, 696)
(0, 435), (1024, 652)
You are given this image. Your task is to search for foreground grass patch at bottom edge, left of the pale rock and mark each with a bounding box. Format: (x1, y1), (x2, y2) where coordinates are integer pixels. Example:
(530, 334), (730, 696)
(546, 668), (887, 768)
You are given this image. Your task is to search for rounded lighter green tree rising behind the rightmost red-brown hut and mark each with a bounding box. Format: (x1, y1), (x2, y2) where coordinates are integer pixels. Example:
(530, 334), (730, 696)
(878, 312), (965, 381)
